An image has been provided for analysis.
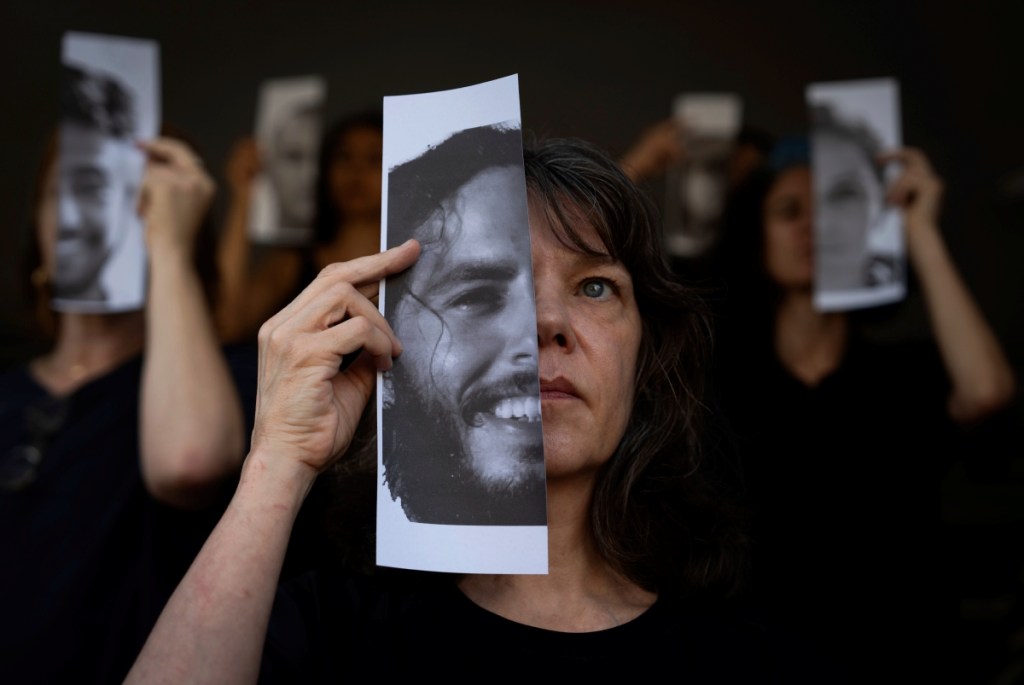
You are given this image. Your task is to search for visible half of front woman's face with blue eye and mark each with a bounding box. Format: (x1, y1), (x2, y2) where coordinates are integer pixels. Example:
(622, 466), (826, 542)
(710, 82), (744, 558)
(529, 200), (641, 485)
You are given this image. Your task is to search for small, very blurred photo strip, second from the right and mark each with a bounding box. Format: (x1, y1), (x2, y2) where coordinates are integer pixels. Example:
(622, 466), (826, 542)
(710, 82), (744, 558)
(665, 93), (742, 258)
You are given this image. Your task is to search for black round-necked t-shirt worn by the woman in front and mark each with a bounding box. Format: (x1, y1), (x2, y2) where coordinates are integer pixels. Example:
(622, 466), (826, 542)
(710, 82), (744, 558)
(260, 569), (845, 684)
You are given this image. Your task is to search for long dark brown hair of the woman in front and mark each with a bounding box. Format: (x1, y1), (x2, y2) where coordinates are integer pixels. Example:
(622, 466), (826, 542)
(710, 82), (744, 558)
(524, 139), (746, 595)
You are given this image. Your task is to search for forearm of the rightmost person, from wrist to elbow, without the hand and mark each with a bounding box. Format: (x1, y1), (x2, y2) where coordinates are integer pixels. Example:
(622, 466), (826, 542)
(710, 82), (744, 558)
(907, 224), (1016, 423)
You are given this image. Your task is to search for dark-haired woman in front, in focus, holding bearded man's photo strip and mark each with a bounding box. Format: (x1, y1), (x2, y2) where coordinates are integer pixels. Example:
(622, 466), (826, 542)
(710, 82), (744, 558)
(126, 135), (835, 684)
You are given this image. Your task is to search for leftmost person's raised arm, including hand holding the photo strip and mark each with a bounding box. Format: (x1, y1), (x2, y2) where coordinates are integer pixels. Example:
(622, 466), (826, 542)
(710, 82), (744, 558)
(139, 138), (246, 508)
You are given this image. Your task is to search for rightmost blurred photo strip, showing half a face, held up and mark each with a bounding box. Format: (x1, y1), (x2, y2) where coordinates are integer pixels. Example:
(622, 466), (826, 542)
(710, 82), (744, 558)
(807, 79), (906, 311)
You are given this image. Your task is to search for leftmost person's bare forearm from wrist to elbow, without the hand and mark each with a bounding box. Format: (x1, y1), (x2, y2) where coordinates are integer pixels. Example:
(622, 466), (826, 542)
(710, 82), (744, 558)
(140, 251), (246, 507)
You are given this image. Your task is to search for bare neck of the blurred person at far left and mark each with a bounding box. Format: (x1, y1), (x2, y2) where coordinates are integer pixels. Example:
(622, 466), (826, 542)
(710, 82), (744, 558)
(30, 311), (145, 395)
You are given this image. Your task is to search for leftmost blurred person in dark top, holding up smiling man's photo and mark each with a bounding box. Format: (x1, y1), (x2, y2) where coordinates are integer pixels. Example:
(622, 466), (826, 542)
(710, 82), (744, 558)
(0, 129), (255, 684)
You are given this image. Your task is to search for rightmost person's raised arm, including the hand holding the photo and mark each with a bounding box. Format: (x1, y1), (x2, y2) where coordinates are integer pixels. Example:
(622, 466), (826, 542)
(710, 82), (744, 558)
(881, 147), (1016, 424)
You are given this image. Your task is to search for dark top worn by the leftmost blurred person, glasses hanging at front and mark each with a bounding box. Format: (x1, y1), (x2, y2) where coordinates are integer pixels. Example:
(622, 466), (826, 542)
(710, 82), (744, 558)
(0, 346), (256, 684)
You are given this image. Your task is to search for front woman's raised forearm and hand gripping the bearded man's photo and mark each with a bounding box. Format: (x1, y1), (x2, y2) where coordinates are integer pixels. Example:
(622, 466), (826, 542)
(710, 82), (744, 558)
(126, 242), (419, 684)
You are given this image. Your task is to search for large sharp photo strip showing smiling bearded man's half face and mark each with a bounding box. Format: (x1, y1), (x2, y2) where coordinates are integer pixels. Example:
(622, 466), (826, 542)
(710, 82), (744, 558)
(378, 77), (547, 572)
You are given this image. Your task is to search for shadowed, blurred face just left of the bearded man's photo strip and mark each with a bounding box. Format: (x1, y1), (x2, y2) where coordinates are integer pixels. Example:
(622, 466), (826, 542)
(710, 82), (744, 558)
(330, 127), (384, 219)
